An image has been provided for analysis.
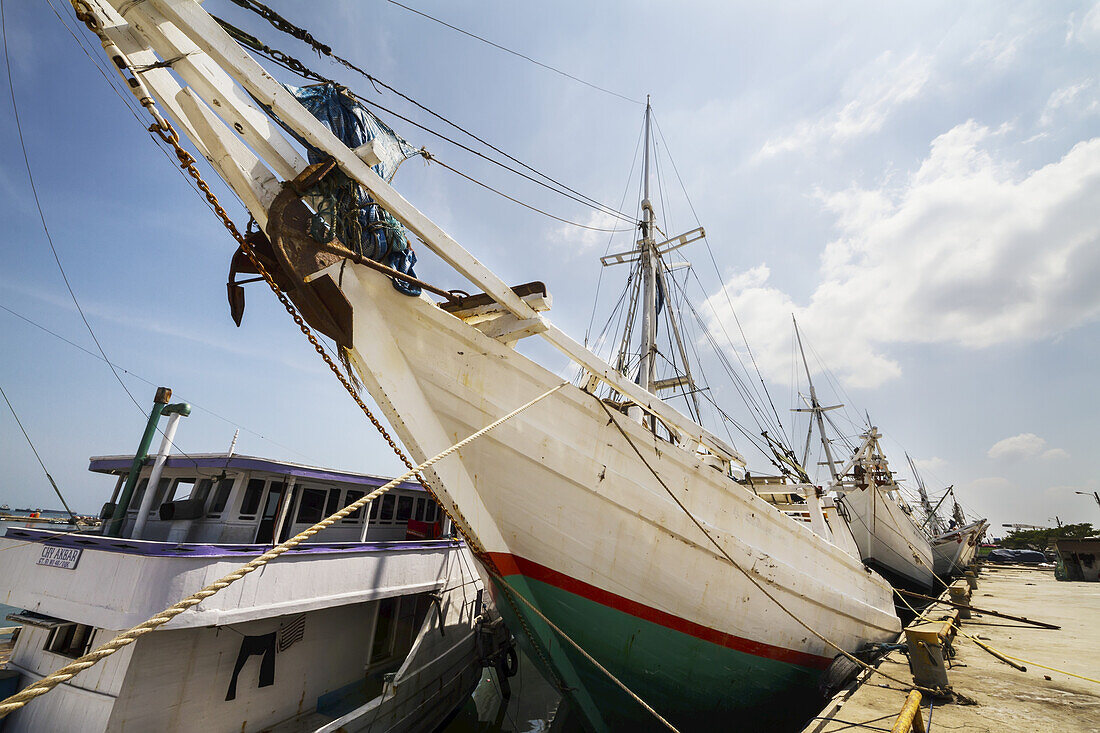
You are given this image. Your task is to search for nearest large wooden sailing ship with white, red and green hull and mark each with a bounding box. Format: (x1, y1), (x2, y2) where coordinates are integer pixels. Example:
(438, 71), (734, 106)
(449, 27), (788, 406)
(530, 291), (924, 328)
(70, 0), (899, 731)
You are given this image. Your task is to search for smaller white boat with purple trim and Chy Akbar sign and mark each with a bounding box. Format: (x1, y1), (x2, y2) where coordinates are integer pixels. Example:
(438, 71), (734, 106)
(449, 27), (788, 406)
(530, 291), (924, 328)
(0, 400), (517, 733)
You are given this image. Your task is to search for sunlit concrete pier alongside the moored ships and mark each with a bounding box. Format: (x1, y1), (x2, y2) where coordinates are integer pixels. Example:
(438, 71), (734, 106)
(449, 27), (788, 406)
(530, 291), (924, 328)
(804, 566), (1100, 733)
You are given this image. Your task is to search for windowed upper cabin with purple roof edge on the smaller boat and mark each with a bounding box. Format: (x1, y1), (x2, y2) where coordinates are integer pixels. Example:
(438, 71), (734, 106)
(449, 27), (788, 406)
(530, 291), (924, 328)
(88, 453), (447, 545)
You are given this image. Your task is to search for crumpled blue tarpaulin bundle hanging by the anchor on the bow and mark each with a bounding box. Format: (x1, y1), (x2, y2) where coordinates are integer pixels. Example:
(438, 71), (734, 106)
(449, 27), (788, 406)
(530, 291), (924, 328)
(287, 84), (420, 295)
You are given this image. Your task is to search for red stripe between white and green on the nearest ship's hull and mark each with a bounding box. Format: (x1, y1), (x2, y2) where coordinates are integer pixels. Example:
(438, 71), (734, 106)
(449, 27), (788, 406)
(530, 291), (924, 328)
(488, 553), (833, 669)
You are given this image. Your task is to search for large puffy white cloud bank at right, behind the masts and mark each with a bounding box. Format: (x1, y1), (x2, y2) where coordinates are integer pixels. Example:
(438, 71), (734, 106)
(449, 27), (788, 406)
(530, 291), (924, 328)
(707, 121), (1100, 387)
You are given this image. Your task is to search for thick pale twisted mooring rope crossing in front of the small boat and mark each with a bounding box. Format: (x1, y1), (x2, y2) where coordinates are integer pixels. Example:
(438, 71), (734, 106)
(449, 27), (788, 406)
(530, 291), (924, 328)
(0, 382), (569, 719)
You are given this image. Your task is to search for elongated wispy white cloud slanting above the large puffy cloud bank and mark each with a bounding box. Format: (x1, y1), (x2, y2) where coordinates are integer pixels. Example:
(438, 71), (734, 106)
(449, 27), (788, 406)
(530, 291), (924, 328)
(756, 52), (931, 160)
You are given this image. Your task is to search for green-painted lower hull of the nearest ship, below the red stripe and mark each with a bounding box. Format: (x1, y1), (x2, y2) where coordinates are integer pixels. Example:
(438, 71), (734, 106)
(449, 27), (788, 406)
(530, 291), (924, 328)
(496, 575), (822, 731)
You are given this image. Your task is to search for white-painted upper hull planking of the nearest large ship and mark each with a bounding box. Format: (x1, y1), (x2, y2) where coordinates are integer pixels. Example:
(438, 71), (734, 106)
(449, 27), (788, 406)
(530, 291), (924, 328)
(329, 264), (899, 657)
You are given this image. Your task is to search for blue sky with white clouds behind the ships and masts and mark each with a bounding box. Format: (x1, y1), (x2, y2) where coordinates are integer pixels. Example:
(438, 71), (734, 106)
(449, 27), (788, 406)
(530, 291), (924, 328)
(0, 0), (1100, 537)
